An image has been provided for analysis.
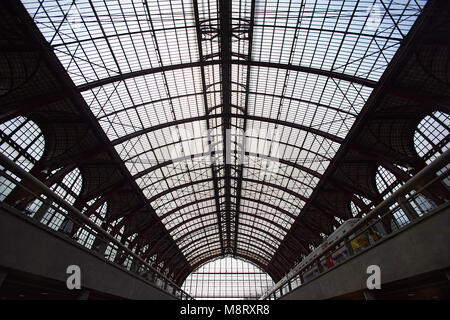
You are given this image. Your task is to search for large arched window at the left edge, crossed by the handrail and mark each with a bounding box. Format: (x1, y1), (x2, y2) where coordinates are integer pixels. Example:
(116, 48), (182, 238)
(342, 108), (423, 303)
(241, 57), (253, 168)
(0, 117), (45, 201)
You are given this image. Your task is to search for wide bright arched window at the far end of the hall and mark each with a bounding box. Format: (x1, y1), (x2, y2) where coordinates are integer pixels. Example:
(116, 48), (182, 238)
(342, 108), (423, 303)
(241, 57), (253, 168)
(183, 257), (274, 300)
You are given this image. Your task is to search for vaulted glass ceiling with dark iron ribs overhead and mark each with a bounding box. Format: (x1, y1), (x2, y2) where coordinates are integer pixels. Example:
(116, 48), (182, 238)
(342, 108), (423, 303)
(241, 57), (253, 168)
(23, 0), (425, 266)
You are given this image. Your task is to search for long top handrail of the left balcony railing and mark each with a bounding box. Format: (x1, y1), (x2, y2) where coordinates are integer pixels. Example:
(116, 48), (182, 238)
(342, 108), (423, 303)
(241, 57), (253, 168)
(0, 153), (192, 299)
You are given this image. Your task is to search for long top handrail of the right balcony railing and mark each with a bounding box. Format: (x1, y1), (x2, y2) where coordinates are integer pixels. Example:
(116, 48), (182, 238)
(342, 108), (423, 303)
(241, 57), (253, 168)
(260, 149), (450, 300)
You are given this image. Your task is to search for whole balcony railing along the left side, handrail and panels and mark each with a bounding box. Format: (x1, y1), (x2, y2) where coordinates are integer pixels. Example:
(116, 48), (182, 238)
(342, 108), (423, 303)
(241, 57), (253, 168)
(0, 154), (193, 300)
